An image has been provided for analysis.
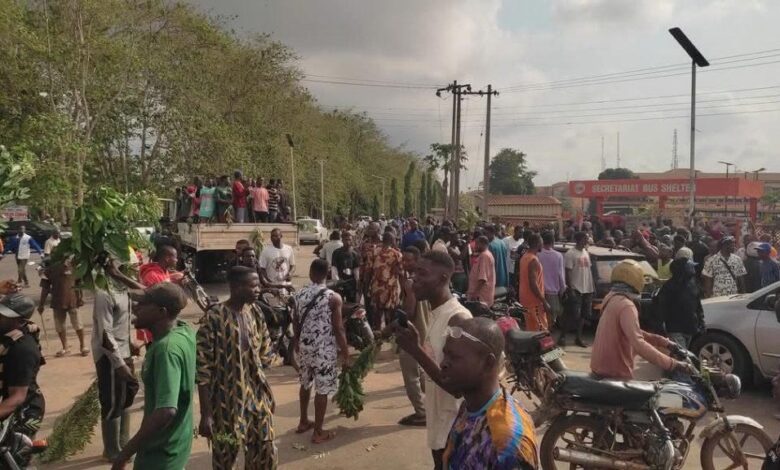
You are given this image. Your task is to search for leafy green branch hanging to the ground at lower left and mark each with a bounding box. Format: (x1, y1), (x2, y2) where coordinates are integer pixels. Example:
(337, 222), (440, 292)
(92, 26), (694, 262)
(40, 381), (100, 463)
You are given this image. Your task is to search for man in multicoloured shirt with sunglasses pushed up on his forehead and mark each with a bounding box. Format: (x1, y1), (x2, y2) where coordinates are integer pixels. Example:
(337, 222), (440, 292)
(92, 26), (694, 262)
(399, 318), (538, 469)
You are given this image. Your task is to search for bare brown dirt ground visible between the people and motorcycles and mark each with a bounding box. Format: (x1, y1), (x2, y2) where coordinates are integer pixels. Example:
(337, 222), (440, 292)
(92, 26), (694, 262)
(0, 246), (780, 470)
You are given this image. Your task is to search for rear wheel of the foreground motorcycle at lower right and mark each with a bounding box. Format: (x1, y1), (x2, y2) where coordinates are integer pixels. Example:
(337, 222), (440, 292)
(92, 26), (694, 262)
(539, 415), (611, 470)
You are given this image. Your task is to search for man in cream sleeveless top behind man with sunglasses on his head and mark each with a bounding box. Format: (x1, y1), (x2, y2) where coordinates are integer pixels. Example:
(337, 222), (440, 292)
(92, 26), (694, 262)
(394, 251), (471, 469)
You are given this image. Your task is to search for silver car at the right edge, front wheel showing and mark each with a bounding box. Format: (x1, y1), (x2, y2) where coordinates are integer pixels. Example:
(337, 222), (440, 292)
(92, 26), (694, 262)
(691, 282), (780, 382)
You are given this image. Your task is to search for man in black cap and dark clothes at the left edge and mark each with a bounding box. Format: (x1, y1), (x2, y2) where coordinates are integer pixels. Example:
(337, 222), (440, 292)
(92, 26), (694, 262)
(0, 293), (45, 437)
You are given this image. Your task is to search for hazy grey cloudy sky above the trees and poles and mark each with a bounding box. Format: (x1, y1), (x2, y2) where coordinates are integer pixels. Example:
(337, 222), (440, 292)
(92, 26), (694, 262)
(191, 0), (780, 189)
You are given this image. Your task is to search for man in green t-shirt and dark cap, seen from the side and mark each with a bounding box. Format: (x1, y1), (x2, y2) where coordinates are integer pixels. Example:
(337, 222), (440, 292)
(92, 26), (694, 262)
(112, 282), (195, 470)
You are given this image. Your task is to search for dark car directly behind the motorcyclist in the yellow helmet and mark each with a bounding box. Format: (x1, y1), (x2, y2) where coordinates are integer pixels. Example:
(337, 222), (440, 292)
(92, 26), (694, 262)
(555, 243), (660, 323)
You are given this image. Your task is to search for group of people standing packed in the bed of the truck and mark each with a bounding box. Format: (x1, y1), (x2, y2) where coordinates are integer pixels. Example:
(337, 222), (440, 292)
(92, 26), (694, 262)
(174, 171), (292, 223)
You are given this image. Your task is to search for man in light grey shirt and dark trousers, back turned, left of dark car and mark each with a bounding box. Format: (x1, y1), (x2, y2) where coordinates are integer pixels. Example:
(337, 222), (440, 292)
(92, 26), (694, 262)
(558, 232), (596, 348)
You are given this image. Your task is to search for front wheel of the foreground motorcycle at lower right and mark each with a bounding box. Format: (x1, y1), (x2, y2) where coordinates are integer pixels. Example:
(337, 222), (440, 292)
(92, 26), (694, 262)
(701, 424), (774, 470)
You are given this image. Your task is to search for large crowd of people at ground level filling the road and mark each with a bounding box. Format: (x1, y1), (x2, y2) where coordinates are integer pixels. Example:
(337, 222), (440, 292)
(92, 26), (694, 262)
(0, 207), (780, 469)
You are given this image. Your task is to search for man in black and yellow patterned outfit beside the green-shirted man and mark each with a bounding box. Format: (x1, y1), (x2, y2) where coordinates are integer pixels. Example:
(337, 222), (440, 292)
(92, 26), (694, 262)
(196, 266), (277, 469)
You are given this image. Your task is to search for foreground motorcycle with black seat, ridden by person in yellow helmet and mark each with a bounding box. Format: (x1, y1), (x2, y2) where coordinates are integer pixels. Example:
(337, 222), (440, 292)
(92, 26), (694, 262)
(539, 349), (773, 470)
